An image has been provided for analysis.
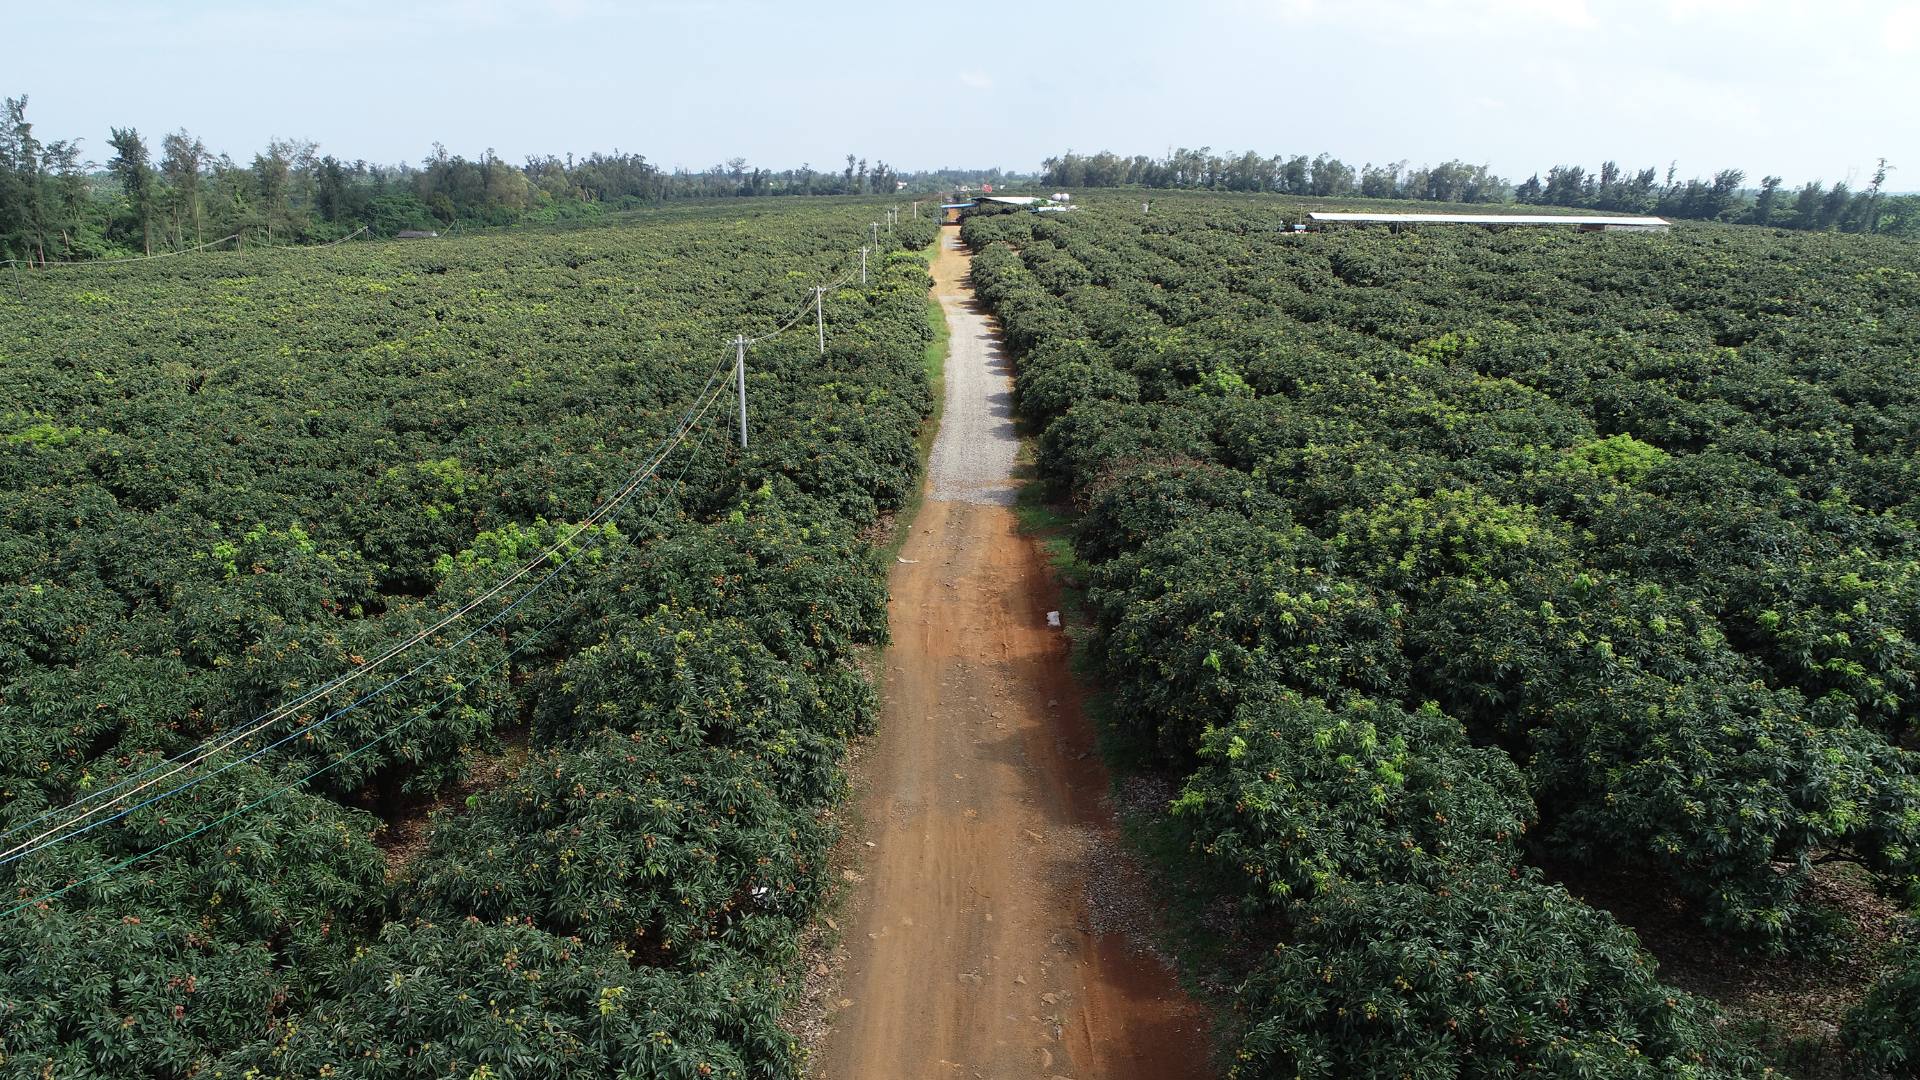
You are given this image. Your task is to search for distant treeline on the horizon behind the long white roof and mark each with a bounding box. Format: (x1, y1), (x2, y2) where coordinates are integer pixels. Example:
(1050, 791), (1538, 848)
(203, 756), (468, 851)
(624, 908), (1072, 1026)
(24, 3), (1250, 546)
(1041, 146), (1920, 236)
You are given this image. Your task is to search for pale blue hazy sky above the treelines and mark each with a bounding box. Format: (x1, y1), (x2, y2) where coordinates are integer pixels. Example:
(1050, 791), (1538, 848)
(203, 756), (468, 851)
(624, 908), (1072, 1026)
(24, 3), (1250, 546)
(15, 0), (1920, 188)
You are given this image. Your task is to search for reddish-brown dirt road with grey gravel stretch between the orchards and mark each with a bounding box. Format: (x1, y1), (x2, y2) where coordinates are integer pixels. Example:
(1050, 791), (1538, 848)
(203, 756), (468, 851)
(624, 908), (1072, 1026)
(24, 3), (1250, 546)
(814, 233), (1206, 1080)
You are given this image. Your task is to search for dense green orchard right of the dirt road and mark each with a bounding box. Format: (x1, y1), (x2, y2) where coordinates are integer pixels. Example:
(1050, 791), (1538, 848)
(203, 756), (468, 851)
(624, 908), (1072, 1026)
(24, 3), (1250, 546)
(962, 196), (1920, 1080)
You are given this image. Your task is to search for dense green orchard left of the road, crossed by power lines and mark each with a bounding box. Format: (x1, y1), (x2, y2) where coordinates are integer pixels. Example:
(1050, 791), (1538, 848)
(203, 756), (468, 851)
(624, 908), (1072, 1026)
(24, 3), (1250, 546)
(0, 200), (939, 1080)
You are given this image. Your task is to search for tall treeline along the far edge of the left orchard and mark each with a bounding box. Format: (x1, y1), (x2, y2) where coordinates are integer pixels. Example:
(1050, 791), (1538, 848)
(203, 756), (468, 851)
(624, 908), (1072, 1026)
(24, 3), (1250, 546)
(0, 96), (1004, 263)
